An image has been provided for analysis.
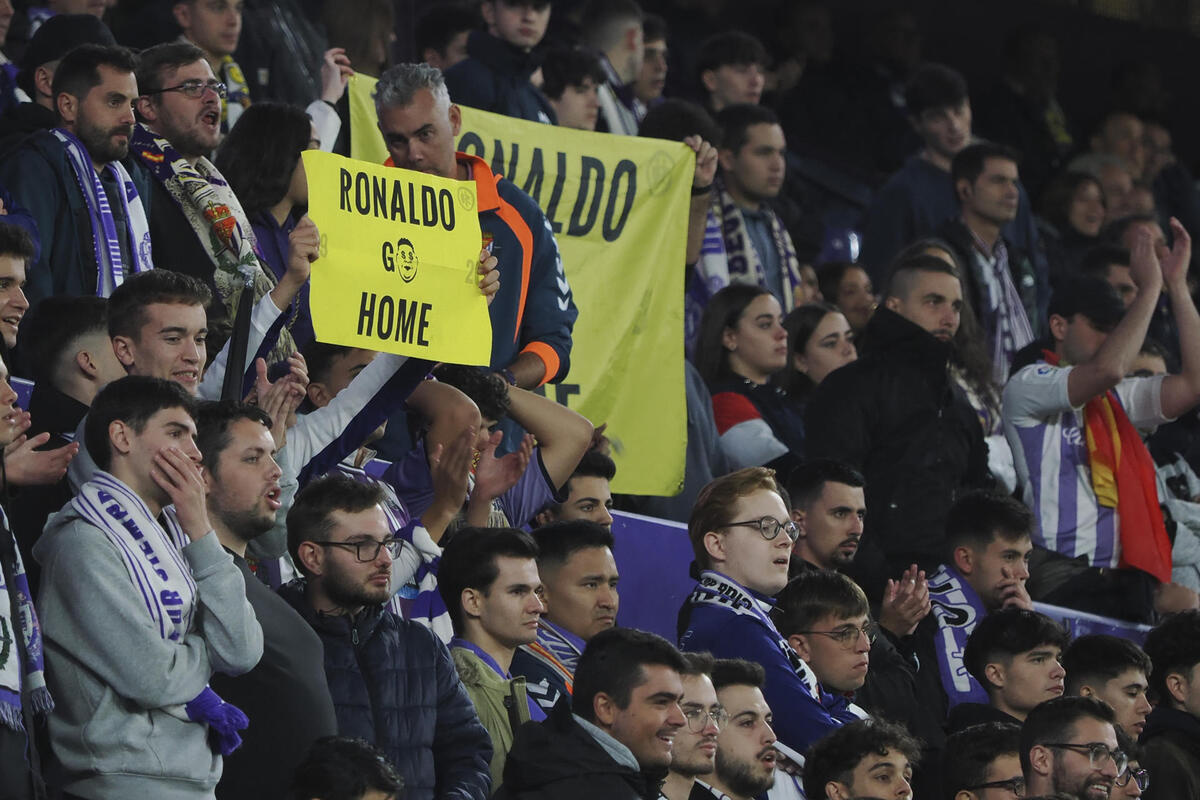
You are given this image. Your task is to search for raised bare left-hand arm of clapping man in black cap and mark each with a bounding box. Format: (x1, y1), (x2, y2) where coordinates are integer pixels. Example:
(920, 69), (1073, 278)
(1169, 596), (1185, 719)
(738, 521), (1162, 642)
(1070, 230), (1161, 408)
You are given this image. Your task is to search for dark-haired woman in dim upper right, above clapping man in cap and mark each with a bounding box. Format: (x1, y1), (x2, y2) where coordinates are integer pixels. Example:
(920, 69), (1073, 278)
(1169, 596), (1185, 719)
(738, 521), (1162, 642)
(1038, 172), (1105, 284)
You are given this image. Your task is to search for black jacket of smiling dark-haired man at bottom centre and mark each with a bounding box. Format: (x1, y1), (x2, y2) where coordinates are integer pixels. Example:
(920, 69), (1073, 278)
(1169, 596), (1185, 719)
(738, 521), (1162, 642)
(493, 703), (660, 800)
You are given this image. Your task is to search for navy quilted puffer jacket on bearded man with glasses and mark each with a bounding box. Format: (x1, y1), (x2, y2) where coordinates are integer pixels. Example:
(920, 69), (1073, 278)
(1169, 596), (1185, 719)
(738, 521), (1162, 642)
(280, 581), (492, 800)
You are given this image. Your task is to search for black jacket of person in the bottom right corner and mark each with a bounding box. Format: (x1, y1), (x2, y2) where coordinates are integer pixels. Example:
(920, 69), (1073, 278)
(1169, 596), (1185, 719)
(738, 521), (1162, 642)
(1141, 705), (1200, 800)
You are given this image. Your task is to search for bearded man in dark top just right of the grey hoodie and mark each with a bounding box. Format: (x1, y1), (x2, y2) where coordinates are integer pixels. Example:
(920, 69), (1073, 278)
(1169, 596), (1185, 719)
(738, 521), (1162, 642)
(196, 402), (337, 800)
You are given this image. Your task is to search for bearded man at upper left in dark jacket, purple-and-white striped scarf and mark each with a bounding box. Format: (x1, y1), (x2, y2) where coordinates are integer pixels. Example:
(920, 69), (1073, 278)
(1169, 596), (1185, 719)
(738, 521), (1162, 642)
(0, 44), (154, 306)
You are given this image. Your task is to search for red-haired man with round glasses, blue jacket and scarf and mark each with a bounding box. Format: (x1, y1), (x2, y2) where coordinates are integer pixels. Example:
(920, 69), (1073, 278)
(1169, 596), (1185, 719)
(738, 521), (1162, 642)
(678, 467), (859, 752)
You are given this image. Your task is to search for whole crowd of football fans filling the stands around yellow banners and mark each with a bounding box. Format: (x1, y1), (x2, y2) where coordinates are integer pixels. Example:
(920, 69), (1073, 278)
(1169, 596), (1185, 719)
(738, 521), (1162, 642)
(0, 0), (1200, 800)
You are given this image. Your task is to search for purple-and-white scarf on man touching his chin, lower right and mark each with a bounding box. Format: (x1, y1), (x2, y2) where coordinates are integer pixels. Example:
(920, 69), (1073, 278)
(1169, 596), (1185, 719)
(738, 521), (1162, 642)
(929, 564), (988, 708)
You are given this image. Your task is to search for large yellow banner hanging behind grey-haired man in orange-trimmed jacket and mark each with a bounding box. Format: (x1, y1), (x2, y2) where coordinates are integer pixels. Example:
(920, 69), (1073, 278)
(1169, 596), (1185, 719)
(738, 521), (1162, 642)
(350, 76), (695, 494)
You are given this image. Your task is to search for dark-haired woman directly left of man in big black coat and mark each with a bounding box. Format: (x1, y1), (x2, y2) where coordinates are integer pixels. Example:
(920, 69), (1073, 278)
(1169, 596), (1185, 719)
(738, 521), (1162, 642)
(776, 302), (858, 416)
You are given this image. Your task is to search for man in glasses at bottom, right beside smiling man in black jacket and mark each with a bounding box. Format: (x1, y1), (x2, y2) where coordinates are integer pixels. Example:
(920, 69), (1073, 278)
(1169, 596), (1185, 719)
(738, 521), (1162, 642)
(662, 652), (730, 800)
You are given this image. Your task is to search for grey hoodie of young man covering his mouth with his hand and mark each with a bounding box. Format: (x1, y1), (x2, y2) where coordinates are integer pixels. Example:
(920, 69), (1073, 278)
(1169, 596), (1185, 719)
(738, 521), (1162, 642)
(34, 504), (263, 800)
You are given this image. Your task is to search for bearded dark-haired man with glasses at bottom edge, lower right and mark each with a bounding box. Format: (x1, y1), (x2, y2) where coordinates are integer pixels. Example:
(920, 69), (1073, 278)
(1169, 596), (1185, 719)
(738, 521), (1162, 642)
(1021, 697), (1123, 800)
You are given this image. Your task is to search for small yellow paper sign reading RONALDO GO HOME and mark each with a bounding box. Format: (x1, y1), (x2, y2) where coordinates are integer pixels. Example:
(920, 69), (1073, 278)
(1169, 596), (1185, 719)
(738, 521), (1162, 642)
(302, 150), (492, 365)
